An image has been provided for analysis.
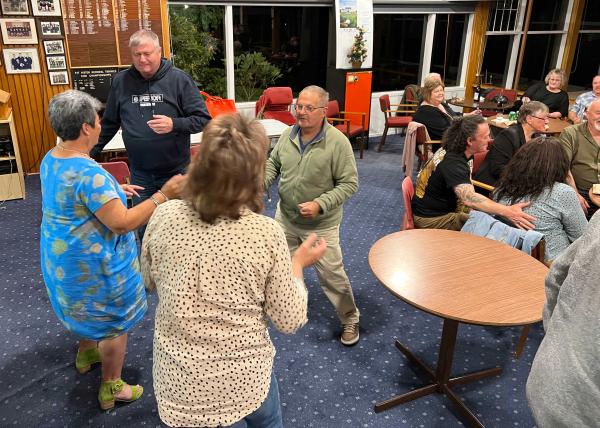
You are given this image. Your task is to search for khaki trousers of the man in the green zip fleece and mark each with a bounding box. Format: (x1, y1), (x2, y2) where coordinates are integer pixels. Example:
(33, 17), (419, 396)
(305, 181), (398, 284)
(275, 208), (360, 324)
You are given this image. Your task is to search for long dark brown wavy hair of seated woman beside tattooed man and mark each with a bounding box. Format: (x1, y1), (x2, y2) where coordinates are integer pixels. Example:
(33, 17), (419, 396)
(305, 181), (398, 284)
(493, 137), (569, 204)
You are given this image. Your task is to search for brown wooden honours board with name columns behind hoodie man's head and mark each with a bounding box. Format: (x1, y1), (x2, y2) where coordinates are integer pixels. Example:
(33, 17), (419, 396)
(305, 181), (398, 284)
(64, 0), (162, 67)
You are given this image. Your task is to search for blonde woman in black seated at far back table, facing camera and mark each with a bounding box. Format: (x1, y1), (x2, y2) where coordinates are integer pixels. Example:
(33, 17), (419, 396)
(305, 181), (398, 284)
(521, 68), (569, 119)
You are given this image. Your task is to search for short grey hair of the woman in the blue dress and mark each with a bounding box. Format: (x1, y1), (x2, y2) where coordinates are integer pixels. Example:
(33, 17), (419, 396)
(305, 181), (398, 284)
(48, 90), (102, 141)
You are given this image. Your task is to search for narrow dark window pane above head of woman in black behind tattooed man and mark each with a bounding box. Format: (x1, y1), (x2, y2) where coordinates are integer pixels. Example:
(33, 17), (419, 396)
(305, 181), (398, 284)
(430, 14), (466, 86)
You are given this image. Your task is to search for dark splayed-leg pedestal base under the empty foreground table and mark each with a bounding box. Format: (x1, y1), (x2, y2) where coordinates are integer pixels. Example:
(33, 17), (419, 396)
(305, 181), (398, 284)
(375, 318), (502, 427)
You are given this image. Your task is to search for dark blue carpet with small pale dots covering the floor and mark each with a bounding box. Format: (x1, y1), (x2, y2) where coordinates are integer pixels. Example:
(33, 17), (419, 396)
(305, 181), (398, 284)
(0, 137), (542, 428)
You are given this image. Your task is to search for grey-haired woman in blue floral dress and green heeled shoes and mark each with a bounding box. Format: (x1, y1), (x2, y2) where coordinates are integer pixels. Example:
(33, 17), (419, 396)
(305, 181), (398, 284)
(40, 91), (184, 409)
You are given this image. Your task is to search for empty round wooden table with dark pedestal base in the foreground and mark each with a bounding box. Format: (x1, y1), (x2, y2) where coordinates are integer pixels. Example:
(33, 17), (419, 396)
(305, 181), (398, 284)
(369, 229), (548, 427)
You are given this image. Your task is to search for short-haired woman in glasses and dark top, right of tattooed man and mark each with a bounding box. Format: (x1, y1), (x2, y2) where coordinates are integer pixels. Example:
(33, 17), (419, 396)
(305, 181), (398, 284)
(473, 101), (548, 186)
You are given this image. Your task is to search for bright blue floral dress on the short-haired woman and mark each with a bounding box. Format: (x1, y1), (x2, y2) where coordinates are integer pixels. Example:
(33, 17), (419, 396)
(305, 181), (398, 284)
(40, 151), (148, 340)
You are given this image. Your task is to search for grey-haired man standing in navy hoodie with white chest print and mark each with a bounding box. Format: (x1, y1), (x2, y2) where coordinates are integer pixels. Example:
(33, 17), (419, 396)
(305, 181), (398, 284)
(92, 30), (211, 238)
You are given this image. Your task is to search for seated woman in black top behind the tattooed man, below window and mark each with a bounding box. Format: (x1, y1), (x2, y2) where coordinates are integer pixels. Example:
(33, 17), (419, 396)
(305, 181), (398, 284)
(413, 79), (480, 140)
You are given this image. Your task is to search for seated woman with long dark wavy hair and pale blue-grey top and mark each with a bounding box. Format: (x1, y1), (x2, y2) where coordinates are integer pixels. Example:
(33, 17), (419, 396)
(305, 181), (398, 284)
(493, 137), (587, 262)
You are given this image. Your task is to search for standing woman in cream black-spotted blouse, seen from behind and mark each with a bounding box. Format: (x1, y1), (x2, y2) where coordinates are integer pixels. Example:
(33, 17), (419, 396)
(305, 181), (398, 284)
(142, 114), (326, 427)
